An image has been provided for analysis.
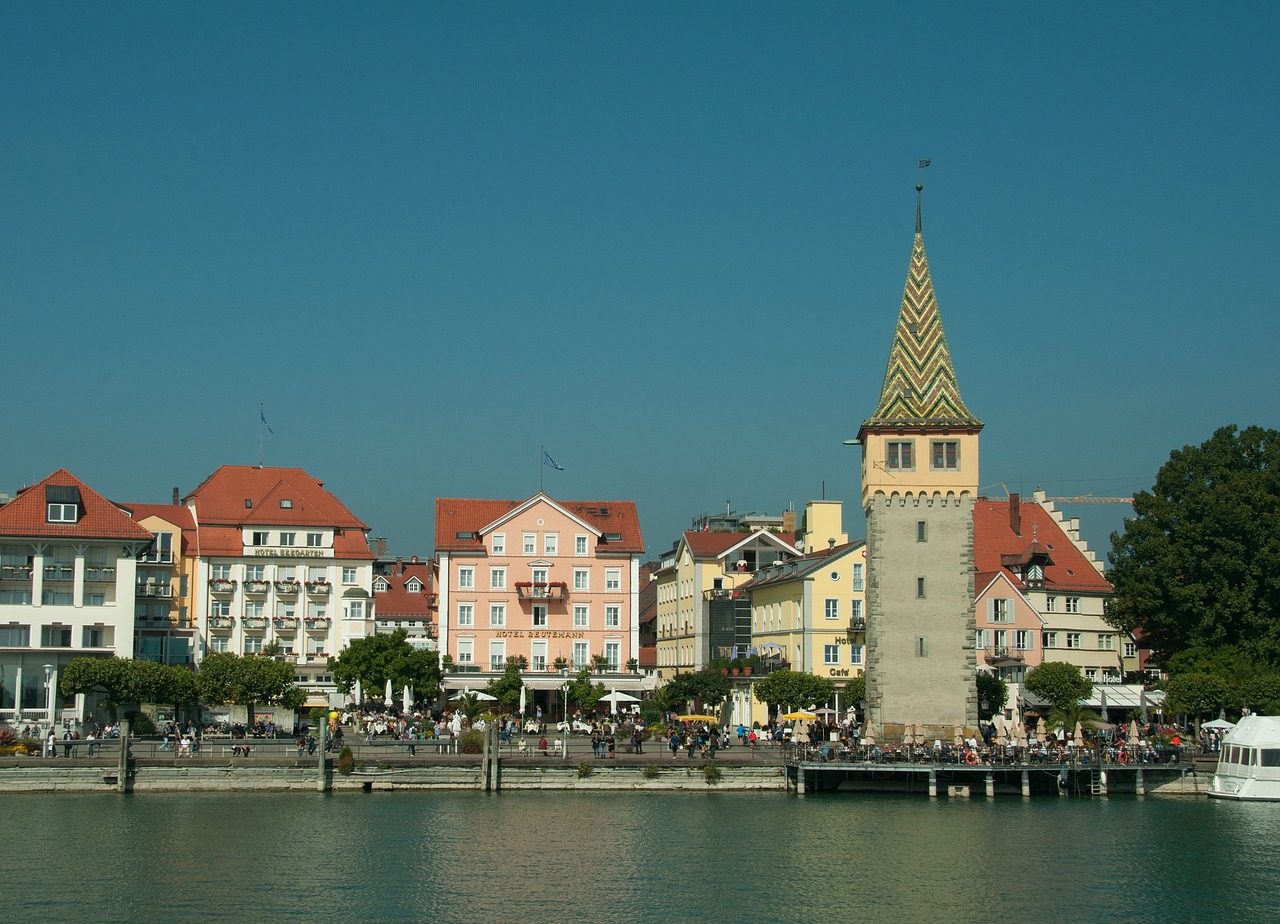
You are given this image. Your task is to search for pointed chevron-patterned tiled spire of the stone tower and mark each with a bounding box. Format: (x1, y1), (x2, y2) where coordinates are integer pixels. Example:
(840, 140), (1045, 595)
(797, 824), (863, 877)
(863, 186), (982, 427)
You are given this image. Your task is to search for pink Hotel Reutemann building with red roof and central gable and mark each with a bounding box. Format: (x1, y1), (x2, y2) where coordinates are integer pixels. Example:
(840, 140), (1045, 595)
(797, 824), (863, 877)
(435, 493), (644, 705)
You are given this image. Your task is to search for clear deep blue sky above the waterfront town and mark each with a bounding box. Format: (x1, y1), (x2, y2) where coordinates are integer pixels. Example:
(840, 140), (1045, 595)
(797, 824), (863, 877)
(0, 3), (1280, 555)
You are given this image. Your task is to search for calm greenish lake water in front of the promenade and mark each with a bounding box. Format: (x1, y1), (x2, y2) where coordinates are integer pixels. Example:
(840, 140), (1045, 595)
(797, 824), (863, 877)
(0, 792), (1280, 924)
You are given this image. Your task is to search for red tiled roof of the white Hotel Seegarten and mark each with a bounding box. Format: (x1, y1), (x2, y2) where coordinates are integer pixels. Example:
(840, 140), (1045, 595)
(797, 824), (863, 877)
(184, 466), (374, 559)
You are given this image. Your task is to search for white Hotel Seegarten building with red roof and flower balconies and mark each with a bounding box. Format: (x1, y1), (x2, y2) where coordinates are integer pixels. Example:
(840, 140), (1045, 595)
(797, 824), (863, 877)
(184, 466), (374, 706)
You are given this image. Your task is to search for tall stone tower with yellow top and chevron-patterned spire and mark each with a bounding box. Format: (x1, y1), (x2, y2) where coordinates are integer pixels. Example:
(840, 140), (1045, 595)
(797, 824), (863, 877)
(858, 186), (982, 736)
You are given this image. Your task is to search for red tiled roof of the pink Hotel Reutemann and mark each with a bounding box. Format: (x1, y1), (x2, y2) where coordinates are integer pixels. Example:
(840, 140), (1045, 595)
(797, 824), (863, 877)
(435, 494), (644, 553)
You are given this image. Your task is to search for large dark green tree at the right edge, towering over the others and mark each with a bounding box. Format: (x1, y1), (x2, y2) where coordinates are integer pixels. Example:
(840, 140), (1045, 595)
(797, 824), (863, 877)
(1107, 425), (1280, 663)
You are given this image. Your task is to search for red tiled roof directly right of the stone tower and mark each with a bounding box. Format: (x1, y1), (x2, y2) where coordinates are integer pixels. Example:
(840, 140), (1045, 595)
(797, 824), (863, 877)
(973, 498), (1111, 594)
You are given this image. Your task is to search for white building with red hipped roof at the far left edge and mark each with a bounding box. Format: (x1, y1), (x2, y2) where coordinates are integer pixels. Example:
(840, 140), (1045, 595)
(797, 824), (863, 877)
(0, 470), (152, 724)
